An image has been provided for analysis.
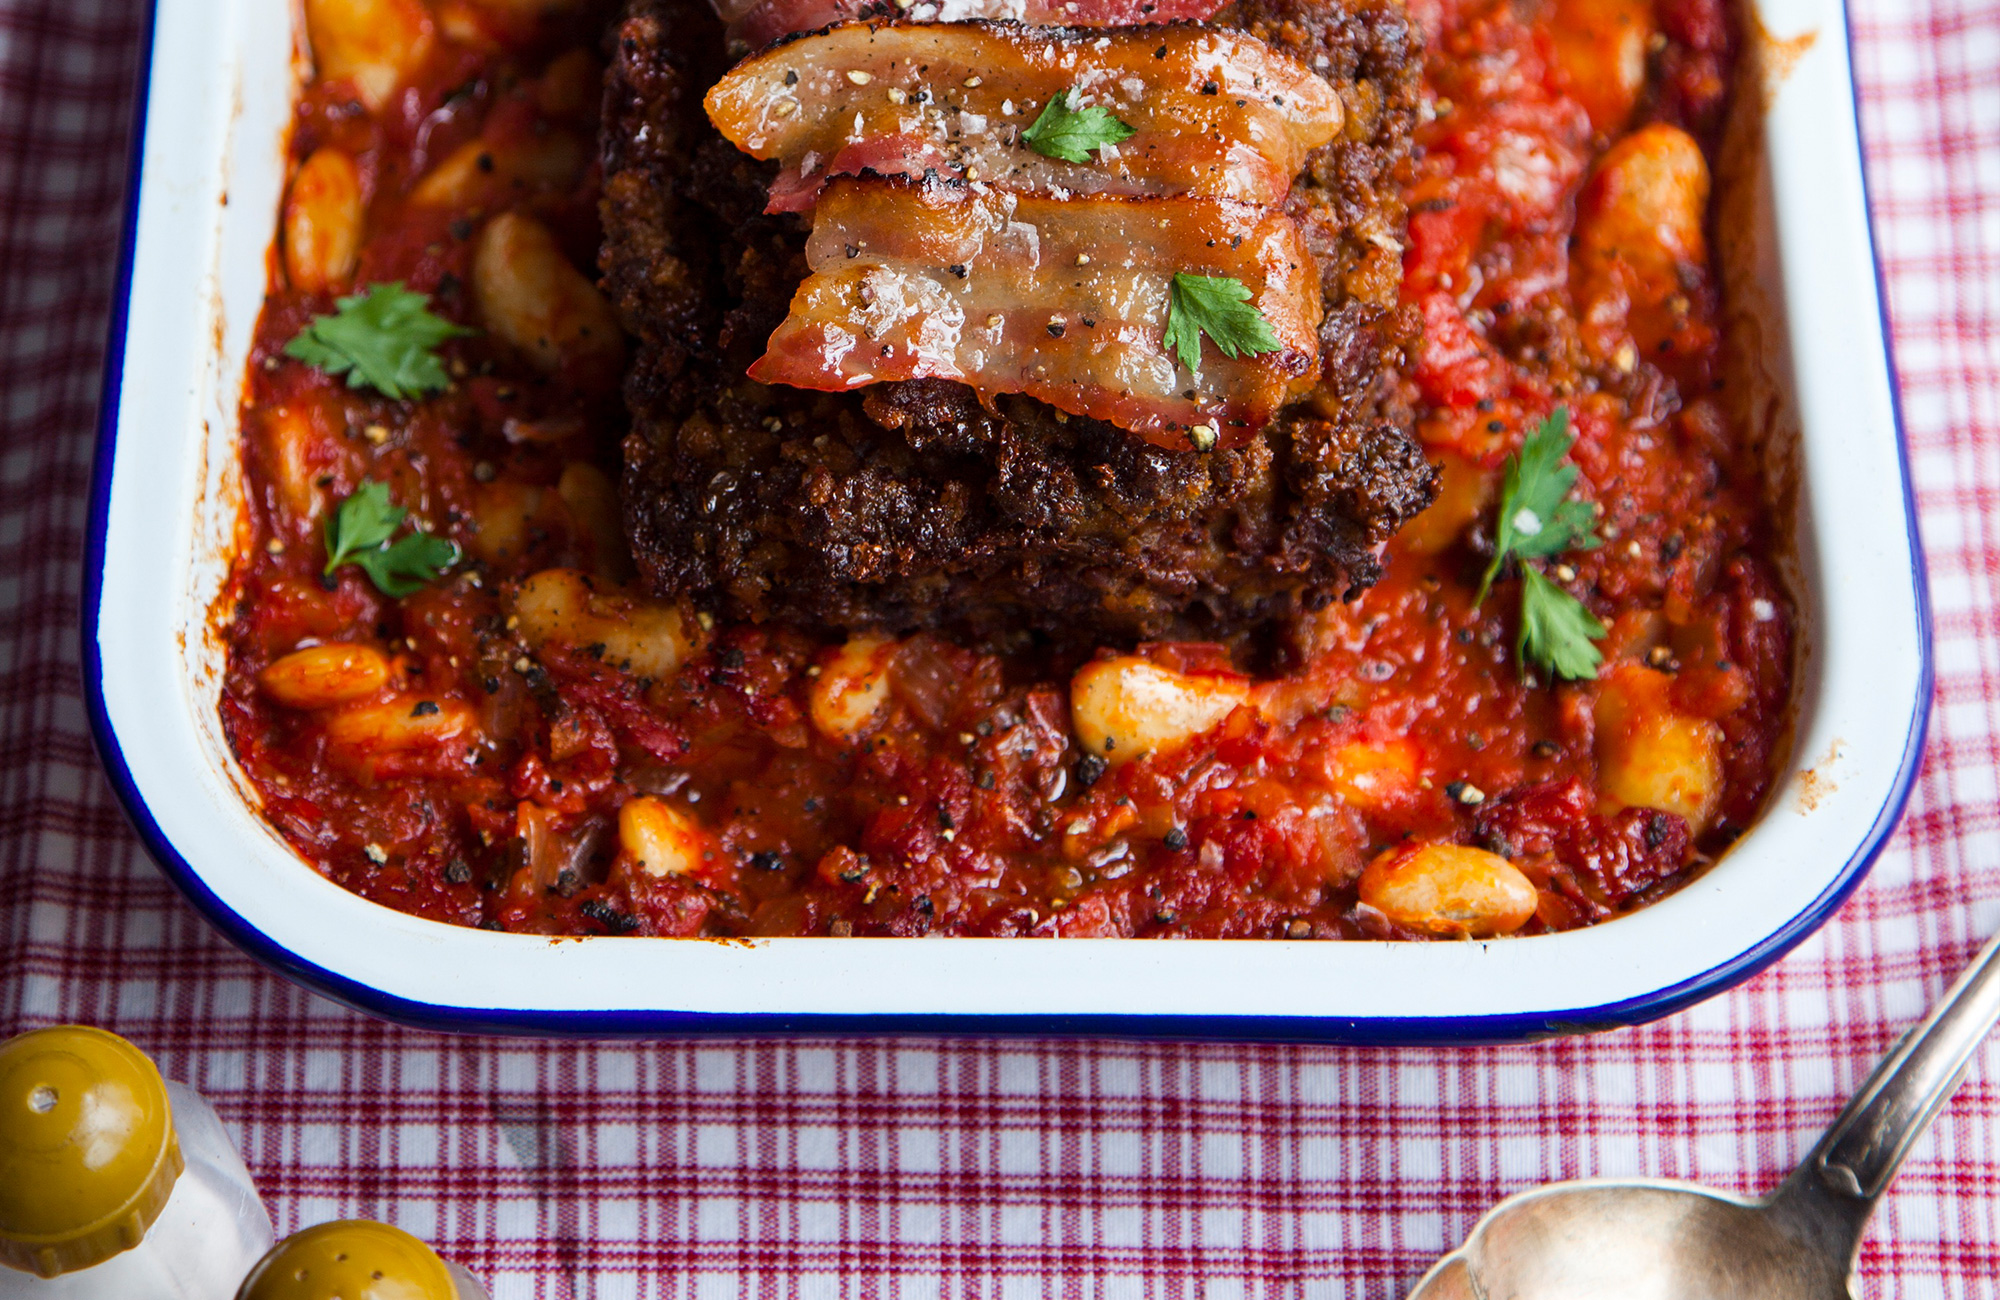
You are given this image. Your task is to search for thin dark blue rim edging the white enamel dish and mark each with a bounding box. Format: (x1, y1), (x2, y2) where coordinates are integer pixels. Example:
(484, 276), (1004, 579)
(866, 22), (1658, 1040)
(82, 4), (1934, 1046)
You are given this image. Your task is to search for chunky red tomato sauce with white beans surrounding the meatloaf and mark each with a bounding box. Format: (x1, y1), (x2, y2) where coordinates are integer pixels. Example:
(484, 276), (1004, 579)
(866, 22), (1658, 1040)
(222, 0), (1792, 938)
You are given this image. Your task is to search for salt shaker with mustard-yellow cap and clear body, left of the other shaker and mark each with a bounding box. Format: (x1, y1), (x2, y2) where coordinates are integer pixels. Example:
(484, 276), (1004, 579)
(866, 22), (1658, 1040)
(0, 1024), (272, 1300)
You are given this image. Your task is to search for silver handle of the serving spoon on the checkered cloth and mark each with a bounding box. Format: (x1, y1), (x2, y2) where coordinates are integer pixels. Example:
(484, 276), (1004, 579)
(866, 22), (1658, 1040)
(1802, 920), (2000, 1202)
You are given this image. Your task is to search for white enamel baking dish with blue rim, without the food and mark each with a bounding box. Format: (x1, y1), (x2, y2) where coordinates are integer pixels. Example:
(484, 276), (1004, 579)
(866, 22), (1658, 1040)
(84, 0), (1930, 1042)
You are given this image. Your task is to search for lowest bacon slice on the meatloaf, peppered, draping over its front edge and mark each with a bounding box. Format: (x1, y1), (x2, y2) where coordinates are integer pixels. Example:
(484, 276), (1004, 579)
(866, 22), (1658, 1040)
(750, 176), (1322, 448)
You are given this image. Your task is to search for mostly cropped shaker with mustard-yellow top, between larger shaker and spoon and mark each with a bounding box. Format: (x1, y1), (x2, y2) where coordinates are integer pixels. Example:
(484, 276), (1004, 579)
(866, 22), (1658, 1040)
(236, 1218), (492, 1300)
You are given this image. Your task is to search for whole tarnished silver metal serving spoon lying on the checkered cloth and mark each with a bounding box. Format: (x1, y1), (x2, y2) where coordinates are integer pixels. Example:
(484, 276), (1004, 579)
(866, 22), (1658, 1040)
(1410, 920), (2000, 1300)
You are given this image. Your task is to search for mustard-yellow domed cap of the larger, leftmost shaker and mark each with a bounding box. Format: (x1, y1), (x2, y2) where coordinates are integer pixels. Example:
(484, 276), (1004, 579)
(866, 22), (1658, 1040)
(0, 1024), (184, 1278)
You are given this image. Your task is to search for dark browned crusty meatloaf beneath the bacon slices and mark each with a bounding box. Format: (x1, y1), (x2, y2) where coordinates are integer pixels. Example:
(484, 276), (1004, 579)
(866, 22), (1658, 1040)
(604, 0), (1434, 640)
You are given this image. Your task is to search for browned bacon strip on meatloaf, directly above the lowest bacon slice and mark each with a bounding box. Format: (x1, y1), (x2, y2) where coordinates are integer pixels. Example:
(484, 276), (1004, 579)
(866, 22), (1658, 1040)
(706, 22), (1344, 212)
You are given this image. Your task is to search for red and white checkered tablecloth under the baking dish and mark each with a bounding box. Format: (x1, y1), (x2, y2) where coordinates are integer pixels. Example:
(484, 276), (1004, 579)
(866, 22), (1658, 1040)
(0, 0), (2000, 1300)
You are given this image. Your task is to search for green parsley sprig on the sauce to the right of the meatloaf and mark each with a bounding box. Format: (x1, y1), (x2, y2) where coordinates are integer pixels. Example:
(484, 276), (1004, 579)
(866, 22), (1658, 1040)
(1474, 406), (1604, 680)
